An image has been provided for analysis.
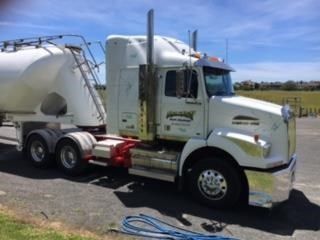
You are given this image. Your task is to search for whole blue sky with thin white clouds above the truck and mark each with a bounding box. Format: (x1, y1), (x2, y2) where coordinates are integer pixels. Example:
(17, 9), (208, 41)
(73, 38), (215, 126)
(0, 0), (320, 81)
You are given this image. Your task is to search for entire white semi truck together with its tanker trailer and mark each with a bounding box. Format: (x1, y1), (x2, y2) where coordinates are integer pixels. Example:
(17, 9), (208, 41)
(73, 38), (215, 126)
(0, 11), (297, 208)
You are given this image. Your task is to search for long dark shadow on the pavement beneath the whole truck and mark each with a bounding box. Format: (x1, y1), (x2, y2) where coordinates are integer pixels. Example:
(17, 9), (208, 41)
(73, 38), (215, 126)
(0, 143), (320, 236)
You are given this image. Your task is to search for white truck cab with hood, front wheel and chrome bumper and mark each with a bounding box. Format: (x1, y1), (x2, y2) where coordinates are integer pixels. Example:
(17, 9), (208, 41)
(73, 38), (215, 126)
(106, 36), (296, 207)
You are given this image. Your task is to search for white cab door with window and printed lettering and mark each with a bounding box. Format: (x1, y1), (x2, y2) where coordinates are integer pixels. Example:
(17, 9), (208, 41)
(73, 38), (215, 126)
(159, 69), (205, 141)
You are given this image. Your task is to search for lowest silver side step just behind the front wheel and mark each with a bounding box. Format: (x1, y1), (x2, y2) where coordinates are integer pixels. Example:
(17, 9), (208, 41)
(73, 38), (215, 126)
(129, 168), (176, 182)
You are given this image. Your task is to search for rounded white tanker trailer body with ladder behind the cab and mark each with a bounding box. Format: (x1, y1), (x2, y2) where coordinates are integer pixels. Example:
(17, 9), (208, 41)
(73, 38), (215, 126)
(0, 38), (106, 127)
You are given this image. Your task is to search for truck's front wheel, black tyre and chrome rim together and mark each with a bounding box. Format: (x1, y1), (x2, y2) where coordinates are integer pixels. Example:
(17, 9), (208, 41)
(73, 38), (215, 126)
(189, 157), (241, 208)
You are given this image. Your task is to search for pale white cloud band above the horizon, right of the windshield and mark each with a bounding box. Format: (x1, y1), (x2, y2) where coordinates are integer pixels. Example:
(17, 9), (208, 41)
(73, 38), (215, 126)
(233, 61), (320, 82)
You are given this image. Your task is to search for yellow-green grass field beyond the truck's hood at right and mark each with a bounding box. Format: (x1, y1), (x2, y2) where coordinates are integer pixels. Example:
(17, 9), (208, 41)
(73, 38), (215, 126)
(236, 90), (320, 113)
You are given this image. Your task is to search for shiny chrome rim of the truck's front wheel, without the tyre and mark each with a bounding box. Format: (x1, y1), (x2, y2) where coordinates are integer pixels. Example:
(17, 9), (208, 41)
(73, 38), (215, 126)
(198, 169), (228, 200)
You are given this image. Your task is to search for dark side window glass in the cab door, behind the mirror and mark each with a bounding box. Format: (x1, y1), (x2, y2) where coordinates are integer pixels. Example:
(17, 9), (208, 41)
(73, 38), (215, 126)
(165, 70), (198, 98)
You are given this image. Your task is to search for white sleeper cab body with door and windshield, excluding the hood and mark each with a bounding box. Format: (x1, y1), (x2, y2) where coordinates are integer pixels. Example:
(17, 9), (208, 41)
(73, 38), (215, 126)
(107, 36), (234, 141)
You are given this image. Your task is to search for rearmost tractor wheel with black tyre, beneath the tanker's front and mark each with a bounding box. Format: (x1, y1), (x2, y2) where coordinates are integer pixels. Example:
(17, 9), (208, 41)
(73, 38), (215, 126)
(26, 134), (53, 168)
